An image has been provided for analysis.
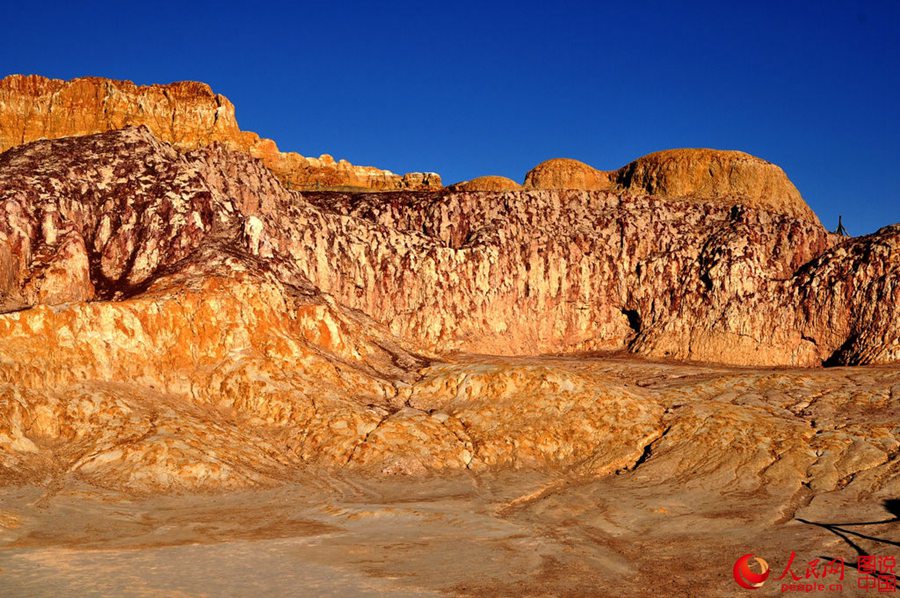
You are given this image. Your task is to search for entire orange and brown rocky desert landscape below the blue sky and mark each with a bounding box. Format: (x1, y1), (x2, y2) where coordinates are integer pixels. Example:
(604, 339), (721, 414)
(0, 76), (900, 596)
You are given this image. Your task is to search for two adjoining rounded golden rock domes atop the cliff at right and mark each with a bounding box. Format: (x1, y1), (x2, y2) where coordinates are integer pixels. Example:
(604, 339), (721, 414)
(525, 149), (819, 223)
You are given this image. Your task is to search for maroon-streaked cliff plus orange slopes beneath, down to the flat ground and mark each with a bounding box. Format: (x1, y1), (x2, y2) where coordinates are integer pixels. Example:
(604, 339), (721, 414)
(0, 127), (900, 494)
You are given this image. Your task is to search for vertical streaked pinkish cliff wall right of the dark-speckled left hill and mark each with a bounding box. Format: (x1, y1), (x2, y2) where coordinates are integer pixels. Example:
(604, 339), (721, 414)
(298, 191), (888, 365)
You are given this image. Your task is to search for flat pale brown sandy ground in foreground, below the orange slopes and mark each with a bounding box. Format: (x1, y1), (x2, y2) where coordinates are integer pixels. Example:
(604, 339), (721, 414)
(0, 475), (900, 596)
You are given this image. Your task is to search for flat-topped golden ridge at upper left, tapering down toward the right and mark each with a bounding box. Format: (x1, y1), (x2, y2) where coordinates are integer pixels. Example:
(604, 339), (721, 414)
(0, 75), (441, 190)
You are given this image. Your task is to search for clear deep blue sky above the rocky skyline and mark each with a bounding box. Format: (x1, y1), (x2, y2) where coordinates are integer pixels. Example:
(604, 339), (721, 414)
(0, 0), (900, 234)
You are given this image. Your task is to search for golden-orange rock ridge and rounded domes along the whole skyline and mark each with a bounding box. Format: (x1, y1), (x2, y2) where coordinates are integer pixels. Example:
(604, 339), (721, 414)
(0, 75), (818, 223)
